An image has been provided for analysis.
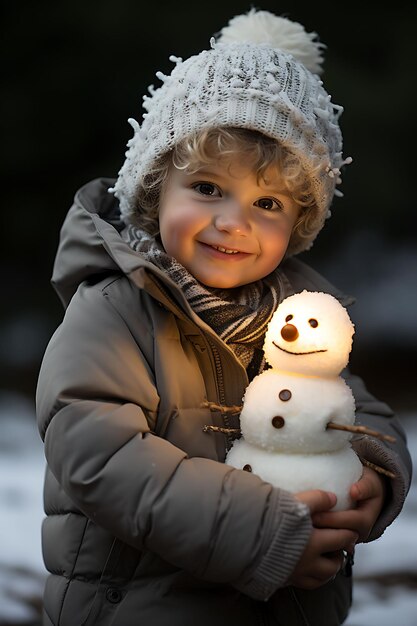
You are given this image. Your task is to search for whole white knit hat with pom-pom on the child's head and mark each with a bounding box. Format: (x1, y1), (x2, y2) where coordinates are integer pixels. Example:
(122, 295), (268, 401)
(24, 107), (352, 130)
(110, 9), (351, 254)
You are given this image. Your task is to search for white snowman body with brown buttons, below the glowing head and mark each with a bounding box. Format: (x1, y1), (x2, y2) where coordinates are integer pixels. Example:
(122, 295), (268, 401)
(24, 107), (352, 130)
(226, 370), (362, 510)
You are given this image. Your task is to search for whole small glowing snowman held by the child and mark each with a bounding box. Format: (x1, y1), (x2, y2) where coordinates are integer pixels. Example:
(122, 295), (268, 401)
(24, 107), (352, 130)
(226, 291), (363, 510)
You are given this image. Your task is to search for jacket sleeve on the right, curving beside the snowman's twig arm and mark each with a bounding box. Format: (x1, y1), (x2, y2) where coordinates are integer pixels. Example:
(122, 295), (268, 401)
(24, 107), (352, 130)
(344, 371), (412, 541)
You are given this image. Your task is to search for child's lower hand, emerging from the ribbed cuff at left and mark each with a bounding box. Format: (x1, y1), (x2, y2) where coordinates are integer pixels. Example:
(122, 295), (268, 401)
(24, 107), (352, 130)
(288, 490), (358, 589)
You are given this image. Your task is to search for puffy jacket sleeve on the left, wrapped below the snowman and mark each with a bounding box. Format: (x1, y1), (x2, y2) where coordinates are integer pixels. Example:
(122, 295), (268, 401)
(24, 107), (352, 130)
(37, 285), (311, 600)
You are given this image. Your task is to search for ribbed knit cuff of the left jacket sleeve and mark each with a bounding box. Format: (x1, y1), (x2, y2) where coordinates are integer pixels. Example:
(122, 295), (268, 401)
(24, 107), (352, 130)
(233, 489), (312, 601)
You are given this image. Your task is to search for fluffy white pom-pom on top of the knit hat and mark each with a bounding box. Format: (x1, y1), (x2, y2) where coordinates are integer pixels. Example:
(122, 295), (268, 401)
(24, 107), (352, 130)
(216, 9), (325, 74)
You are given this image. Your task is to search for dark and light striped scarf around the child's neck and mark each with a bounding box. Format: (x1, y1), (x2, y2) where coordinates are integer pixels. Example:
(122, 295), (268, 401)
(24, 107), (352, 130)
(122, 225), (282, 380)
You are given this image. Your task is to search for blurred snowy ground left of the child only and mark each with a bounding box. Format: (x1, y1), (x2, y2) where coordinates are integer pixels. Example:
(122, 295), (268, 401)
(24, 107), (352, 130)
(0, 394), (45, 625)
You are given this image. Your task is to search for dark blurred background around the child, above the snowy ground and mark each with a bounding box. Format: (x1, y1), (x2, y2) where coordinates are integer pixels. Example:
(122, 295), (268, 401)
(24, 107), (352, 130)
(0, 0), (417, 409)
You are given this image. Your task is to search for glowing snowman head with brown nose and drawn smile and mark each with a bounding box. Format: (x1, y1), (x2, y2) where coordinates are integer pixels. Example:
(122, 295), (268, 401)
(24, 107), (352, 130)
(264, 291), (354, 376)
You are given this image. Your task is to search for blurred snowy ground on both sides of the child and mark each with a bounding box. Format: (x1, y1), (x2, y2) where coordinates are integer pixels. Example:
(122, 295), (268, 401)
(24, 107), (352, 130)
(0, 394), (417, 626)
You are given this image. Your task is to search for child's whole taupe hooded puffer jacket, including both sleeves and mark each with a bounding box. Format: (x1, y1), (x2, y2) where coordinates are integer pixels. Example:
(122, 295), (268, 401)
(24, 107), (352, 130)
(37, 179), (409, 626)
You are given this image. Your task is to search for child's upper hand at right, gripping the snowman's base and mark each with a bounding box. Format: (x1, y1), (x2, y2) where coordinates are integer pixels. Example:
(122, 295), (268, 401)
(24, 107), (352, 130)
(312, 467), (386, 542)
